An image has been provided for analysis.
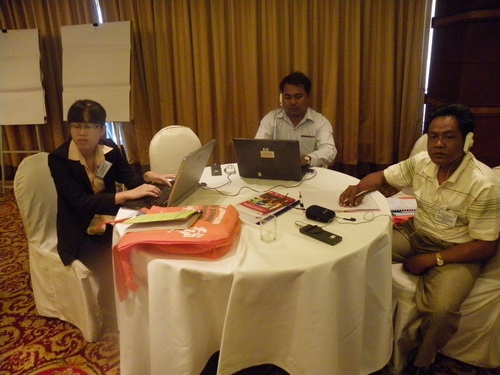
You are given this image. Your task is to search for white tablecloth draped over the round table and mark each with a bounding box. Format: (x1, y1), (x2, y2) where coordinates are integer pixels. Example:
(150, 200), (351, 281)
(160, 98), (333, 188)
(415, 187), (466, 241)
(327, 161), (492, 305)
(115, 166), (392, 375)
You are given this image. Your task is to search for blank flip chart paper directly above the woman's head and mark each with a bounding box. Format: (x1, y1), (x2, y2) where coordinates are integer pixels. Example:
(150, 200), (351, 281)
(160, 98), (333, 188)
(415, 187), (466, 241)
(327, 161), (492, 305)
(61, 21), (131, 122)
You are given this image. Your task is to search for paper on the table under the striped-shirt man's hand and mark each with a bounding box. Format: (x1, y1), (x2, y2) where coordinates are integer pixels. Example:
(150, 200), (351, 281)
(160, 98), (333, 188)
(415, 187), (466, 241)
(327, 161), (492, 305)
(300, 190), (380, 212)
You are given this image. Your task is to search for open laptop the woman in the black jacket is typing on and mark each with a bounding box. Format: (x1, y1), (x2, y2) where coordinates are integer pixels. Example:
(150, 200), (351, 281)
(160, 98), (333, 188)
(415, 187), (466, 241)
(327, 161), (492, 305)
(122, 139), (215, 210)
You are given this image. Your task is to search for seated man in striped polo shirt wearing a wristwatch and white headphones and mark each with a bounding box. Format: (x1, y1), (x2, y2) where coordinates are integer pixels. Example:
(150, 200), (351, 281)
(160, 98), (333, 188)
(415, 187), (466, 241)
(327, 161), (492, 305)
(340, 104), (500, 374)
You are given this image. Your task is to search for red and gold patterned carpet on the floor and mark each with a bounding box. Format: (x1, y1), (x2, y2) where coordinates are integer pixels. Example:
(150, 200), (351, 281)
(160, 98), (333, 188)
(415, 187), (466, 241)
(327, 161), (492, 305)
(0, 190), (500, 375)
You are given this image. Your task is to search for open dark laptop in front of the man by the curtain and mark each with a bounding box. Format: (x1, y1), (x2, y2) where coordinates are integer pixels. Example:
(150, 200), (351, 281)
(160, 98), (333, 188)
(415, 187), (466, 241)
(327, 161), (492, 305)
(233, 138), (308, 181)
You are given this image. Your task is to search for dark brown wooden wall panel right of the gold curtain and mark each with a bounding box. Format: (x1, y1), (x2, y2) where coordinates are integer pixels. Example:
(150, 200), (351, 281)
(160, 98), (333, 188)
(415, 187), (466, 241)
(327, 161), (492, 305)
(426, 0), (500, 167)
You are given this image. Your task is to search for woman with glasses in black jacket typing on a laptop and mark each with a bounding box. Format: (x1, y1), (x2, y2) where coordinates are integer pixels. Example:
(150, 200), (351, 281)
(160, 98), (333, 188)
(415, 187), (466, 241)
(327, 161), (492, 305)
(48, 100), (175, 318)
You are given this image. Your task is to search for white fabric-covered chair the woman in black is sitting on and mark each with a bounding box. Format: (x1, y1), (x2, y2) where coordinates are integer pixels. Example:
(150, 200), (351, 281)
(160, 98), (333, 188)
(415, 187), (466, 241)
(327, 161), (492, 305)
(14, 152), (102, 341)
